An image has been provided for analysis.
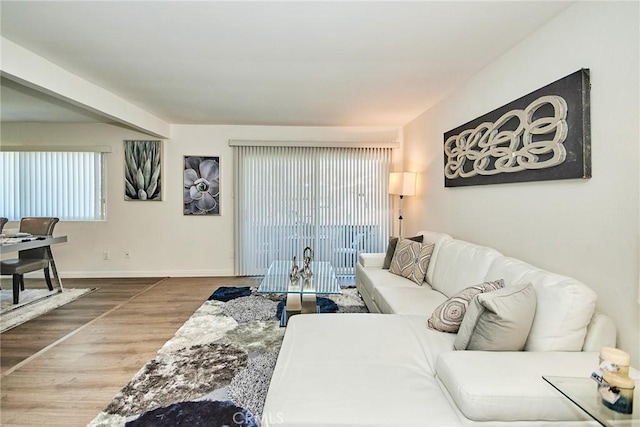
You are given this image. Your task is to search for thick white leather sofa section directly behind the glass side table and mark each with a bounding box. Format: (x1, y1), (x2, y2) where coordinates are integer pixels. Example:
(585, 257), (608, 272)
(436, 351), (598, 426)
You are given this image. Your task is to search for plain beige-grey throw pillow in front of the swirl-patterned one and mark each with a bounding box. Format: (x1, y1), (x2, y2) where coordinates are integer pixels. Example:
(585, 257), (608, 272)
(454, 283), (536, 351)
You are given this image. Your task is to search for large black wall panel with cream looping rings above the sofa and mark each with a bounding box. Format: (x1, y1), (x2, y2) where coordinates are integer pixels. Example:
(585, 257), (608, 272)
(444, 69), (591, 187)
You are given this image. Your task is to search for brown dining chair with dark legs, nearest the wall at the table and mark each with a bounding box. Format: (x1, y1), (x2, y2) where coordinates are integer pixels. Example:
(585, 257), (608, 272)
(0, 217), (59, 304)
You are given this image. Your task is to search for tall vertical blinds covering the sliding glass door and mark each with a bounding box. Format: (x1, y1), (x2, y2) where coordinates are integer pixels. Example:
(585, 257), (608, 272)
(234, 146), (392, 276)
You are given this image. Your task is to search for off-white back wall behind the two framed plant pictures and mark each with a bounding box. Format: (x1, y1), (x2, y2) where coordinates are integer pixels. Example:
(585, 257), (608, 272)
(1, 123), (399, 278)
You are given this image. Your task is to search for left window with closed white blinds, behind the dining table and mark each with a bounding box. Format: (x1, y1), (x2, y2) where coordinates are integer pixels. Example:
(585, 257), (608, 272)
(0, 151), (105, 221)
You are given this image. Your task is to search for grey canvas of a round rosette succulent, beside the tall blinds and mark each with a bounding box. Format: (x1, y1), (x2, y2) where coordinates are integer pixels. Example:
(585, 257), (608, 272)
(183, 156), (220, 215)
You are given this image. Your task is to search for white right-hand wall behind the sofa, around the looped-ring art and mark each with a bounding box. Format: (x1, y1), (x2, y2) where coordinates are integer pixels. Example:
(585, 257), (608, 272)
(404, 2), (640, 367)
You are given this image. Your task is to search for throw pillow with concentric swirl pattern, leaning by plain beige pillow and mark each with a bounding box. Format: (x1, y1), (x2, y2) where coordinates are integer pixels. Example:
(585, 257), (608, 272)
(427, 279), (504, 334)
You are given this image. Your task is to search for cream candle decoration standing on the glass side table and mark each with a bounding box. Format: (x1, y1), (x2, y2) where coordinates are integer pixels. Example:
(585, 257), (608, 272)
(591, 347), (635, 414)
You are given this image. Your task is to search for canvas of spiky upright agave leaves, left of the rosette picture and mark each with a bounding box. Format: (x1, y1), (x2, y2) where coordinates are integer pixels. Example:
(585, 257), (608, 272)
(124, 141), (162, 201)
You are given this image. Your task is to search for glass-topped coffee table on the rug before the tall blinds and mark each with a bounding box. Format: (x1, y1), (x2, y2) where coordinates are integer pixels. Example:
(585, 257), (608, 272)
(258, 261), (342, 326)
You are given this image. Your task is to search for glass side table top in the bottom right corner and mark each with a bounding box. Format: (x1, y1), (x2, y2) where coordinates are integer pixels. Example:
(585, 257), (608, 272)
(542, 375), (640, 427)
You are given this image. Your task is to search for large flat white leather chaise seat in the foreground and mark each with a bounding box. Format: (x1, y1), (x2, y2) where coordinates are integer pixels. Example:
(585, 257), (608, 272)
(262, 314), (460, 427)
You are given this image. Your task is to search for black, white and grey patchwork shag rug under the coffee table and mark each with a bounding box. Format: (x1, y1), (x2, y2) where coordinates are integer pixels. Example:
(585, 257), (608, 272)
(89, 287), (367, 427)
